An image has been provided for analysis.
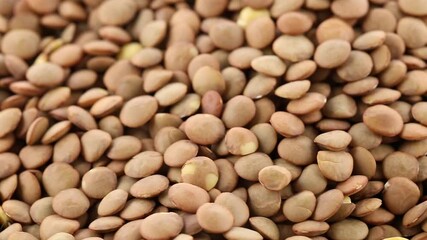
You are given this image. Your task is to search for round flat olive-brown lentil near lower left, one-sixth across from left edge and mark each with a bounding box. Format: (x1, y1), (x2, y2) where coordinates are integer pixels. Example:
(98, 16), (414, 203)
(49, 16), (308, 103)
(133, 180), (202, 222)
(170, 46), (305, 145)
(52, 188), (90, 218)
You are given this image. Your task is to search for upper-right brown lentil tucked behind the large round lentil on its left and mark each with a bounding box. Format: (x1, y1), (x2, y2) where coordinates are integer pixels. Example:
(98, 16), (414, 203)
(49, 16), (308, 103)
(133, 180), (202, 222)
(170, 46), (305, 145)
(337, 51), (373, 82)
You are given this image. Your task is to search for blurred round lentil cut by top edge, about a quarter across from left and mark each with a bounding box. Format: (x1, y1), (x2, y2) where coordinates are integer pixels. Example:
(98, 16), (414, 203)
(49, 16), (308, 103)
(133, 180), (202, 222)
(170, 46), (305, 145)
(98, 0), (137, 25)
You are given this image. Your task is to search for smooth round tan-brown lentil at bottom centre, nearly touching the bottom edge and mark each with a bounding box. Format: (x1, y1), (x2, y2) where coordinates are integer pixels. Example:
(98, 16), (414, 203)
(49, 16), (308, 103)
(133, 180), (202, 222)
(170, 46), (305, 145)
(196, 203), (234, 233)
